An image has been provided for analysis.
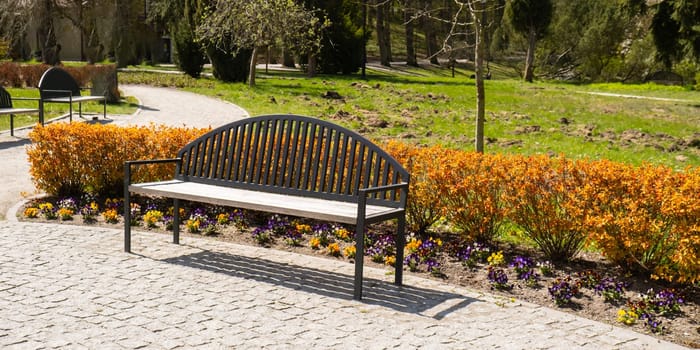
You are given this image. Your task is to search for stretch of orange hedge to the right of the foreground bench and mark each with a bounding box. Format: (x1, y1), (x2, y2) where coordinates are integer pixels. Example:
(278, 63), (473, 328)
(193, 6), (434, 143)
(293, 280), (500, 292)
(385, 142), (700, 283)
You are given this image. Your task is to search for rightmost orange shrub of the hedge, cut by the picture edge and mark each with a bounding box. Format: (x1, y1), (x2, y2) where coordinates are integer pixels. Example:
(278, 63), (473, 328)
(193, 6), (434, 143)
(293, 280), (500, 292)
(585, 161), (700, 283)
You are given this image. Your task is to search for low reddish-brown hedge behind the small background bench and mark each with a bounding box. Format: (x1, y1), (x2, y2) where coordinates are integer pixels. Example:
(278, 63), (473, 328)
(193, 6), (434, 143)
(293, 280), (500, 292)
(0, 62), (116, 88)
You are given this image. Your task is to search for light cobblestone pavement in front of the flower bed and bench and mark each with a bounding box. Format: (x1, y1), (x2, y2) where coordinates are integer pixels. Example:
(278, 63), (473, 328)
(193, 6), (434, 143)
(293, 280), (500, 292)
(0, 222), (681, 349)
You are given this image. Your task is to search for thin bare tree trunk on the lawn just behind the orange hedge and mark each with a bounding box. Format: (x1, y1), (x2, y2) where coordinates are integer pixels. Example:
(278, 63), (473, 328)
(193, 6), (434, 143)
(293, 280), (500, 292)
(473, 1), (486, 153)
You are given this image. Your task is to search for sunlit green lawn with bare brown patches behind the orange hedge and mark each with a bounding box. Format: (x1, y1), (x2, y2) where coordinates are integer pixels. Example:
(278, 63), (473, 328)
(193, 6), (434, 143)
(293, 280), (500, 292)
(37, 66), (700, 169)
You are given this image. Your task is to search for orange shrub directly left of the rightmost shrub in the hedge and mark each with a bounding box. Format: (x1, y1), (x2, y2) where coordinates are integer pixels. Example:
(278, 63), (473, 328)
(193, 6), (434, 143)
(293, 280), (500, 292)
(505, 156), (590, 261)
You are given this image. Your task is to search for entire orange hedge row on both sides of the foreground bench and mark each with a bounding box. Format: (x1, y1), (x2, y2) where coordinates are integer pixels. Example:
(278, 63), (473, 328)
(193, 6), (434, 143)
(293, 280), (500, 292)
(28, 123), (700, 283)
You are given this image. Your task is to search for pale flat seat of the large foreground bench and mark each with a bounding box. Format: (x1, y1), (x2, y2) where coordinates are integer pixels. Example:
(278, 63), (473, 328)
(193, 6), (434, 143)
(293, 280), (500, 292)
(129, 180), (399, 225)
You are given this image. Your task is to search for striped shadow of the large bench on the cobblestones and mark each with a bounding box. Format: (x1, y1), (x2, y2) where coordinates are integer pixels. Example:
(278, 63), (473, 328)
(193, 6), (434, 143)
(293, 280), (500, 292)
(163, 251), (477, 319)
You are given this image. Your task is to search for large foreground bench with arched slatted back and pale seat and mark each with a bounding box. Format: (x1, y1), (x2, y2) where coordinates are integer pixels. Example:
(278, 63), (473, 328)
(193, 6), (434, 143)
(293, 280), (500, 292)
(124, 115), (409, 300)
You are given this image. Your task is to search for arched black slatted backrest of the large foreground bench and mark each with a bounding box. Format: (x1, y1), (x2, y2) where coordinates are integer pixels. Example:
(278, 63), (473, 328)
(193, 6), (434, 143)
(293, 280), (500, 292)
(175, 115), (409, 208)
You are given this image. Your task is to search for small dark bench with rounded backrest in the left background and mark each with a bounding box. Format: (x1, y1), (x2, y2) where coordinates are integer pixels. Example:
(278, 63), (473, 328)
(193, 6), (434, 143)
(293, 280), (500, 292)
(39, 67), (107, 125)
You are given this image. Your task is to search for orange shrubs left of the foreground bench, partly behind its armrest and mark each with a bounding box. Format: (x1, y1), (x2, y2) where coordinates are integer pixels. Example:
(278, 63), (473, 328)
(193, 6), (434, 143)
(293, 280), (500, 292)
(27, 123), (207, 196)
